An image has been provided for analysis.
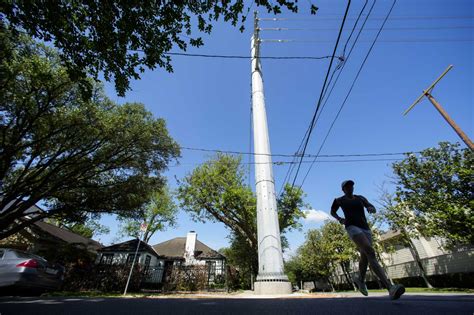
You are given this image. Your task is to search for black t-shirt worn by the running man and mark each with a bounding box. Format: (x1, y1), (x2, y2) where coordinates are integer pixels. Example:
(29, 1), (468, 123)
(331, 195), (370, 230)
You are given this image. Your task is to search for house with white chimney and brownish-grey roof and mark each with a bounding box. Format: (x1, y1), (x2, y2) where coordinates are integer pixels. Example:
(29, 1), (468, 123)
(153, 231), (226, 282)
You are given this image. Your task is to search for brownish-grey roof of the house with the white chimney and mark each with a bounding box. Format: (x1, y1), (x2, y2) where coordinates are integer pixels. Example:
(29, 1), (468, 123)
(153, 237), (225, 259)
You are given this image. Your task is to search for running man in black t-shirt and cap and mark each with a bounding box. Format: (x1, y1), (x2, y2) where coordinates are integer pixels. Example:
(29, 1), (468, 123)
(331, 180), (405, 300)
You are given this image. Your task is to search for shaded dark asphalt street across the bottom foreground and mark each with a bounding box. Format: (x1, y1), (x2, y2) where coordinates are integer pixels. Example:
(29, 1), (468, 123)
(0, 294), (474, 315)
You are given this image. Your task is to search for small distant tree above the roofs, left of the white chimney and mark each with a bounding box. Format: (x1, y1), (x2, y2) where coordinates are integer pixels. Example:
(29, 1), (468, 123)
(121, 186), (178, 243)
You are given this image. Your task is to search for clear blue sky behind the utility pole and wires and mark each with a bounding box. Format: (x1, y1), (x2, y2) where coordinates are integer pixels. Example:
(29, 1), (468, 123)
(99, 0), (474, 253)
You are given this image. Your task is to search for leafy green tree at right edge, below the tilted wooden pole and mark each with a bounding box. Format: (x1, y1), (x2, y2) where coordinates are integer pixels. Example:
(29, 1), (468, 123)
(385, 142), (474, 247)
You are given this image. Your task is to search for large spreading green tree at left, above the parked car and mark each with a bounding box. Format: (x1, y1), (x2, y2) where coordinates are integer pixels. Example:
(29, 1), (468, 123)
(0, 23), (179, 239)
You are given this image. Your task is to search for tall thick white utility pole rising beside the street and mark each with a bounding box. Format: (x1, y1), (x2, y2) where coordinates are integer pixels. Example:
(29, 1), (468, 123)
(251, 12), (291, 294)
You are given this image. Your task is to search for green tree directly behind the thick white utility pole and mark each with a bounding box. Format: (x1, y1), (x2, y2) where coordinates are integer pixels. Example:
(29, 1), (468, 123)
(178, 154), (307, 286)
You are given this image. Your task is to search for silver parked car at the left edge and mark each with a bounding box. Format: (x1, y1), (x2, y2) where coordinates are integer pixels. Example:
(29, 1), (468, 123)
(0, 248), (64, 291)
